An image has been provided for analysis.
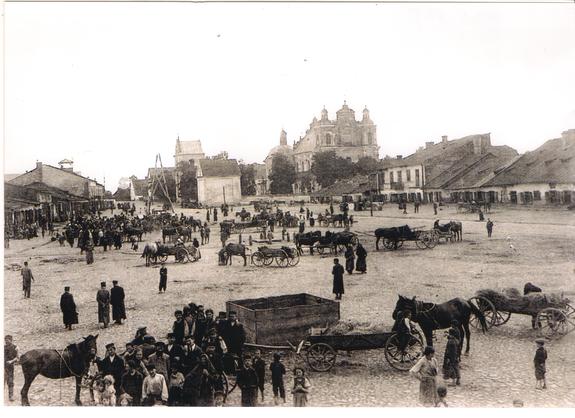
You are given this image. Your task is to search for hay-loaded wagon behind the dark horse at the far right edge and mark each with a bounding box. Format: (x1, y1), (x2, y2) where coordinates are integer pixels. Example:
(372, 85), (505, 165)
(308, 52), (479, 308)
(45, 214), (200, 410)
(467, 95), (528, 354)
(470, 290), (575, 339)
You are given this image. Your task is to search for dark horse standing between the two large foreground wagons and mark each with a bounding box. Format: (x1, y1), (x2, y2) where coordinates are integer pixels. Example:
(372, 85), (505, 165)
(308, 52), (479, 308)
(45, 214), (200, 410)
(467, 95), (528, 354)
(392, 295), (487, 354)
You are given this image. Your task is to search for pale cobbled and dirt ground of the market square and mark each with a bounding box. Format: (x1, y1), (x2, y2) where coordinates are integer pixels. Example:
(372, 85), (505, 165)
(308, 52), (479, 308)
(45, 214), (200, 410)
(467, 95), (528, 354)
(4, 201), (575, 407)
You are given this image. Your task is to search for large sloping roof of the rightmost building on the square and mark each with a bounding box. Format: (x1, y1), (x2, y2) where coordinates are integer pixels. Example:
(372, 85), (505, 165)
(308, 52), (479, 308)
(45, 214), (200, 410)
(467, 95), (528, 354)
(486, 136), (575, 186)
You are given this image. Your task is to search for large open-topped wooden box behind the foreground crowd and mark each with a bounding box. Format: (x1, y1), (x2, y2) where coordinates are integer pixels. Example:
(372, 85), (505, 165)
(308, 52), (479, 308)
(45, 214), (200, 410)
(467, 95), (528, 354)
(226, 293), (339, 345)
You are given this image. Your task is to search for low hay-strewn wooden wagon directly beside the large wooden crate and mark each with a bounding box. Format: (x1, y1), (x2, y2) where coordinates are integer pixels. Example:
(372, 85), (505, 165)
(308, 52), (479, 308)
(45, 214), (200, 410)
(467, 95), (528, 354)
(296, 331), (424, 372)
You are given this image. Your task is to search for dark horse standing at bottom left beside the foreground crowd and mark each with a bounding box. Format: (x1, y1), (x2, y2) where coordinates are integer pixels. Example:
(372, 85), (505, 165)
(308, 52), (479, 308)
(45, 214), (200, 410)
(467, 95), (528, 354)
(20, 334), (98, 406)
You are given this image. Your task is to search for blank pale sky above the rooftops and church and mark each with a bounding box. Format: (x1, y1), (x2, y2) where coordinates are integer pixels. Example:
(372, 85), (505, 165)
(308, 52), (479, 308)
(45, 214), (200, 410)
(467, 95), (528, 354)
(4, 3), (575, 192)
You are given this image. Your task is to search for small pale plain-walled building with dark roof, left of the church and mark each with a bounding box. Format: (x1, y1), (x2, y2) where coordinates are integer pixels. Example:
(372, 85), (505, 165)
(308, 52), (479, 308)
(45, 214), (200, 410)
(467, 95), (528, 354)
(197, 159), (242, 206)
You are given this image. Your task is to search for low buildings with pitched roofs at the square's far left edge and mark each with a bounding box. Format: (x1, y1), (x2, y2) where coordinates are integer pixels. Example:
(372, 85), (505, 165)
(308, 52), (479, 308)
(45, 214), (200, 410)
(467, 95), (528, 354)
(4, 160), (112, 229)
